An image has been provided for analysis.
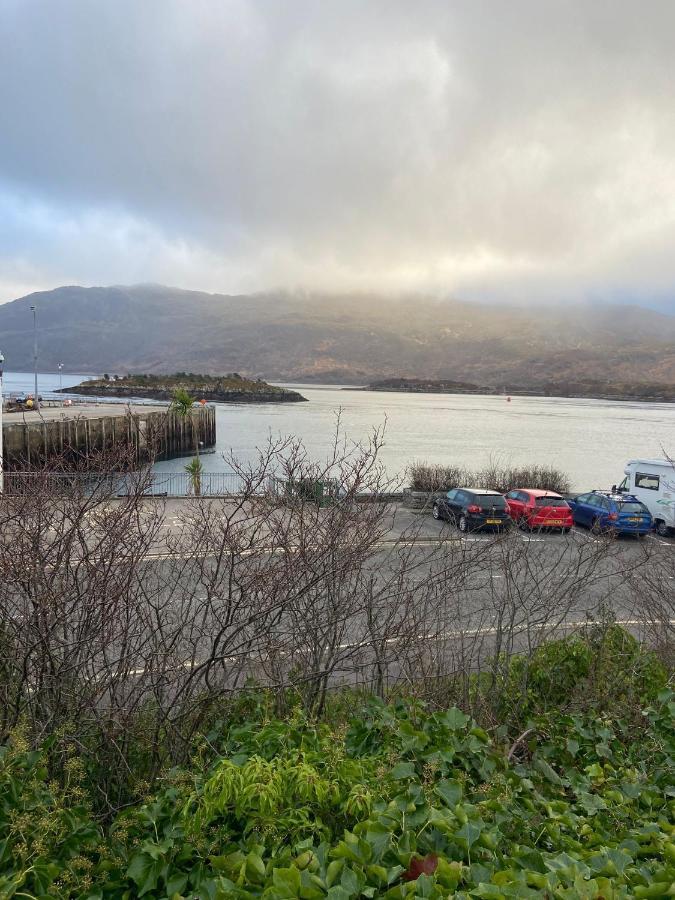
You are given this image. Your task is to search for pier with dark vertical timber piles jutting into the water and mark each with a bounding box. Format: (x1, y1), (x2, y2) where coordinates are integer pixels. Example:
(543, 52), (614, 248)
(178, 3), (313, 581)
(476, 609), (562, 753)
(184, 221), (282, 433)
(3, 404), (216, 471)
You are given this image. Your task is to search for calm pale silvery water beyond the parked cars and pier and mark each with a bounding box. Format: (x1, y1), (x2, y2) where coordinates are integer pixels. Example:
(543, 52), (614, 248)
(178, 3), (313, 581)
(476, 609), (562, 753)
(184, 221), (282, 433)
(4, 372), (675, 489)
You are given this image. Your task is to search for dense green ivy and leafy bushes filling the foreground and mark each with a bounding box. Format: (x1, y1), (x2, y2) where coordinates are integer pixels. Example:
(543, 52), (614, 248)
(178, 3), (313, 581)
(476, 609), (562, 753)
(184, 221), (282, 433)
(0, 624), (675, 900)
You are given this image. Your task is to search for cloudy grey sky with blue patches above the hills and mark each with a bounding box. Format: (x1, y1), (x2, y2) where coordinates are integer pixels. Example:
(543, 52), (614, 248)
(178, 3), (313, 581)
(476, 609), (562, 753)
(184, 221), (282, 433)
(0, 0), (675, 306)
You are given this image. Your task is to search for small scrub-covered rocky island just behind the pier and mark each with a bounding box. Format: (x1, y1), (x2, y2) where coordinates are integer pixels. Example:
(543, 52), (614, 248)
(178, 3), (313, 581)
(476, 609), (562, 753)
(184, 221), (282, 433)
(61, 372), (307, 403)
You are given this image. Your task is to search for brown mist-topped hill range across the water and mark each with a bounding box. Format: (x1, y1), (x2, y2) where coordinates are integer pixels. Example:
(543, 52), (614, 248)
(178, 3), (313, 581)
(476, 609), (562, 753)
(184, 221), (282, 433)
(0, 285), (675, 385)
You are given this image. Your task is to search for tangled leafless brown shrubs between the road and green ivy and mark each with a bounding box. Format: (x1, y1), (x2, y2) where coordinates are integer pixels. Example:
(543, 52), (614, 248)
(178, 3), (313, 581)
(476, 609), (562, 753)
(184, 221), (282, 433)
(0, 429), (648, 812)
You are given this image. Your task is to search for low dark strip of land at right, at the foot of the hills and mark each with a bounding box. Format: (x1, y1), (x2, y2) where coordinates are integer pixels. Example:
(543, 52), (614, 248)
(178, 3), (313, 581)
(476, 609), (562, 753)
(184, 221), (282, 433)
(356, 378), (675, 403)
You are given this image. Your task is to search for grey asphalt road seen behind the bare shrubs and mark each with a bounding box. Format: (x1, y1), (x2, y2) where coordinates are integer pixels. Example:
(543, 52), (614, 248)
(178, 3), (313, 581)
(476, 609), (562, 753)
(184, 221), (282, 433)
(14, 500), (675, 684)
